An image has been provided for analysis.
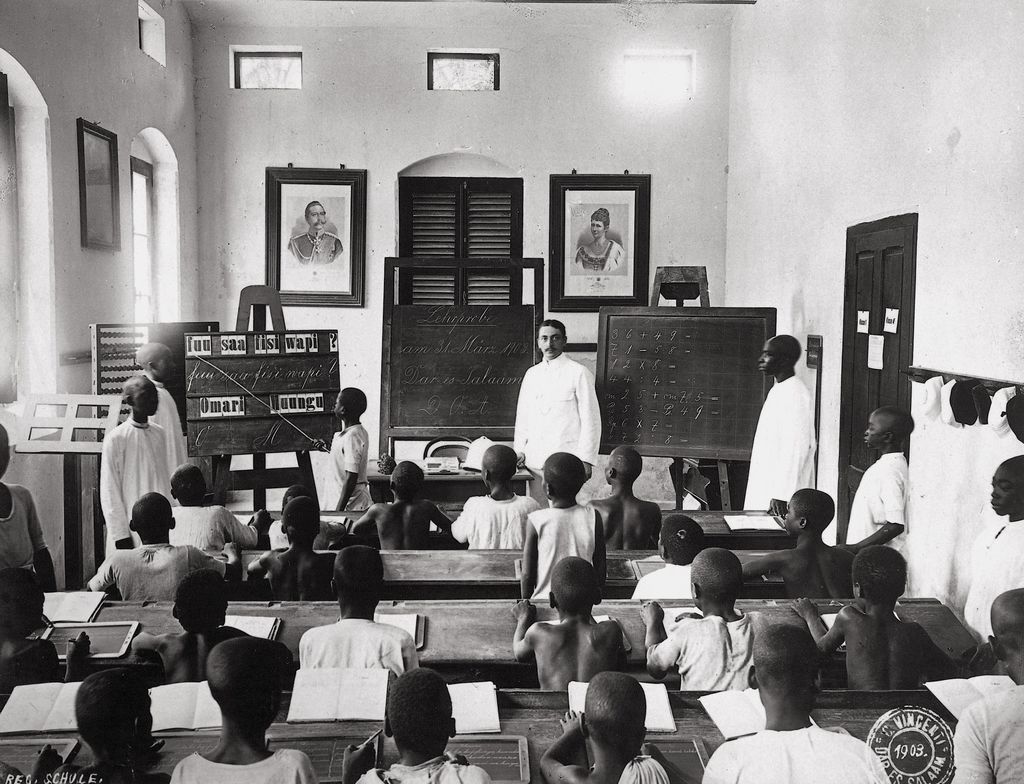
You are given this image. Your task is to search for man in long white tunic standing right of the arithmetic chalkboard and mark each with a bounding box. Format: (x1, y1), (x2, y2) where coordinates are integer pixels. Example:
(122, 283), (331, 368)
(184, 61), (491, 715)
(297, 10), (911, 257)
(743, 335), (814, 515)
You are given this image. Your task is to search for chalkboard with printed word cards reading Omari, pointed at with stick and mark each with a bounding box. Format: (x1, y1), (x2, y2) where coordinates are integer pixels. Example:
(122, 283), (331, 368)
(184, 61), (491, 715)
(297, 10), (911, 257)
(185, 330), (341, 456)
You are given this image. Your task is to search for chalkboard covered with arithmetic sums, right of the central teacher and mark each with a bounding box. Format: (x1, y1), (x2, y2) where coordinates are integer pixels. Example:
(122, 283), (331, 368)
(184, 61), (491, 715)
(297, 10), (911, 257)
(597, 308), (775, 460)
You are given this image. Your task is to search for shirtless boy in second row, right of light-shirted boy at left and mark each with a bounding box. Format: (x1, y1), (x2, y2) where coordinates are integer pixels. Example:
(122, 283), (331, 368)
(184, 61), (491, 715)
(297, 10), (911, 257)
(249, 495), (334, 602)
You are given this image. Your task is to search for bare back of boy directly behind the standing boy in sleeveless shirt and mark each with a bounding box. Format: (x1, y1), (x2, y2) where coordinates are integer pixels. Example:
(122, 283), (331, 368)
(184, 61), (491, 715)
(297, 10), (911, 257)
(525, 620), (626, 691)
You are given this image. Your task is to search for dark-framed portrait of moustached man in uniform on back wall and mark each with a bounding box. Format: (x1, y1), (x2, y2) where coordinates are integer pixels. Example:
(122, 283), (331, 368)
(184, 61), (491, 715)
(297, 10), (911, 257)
(266, 167), (367, 307)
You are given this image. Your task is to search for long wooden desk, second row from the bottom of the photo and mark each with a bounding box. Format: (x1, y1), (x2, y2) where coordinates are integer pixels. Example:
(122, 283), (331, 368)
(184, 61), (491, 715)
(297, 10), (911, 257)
(96, 599), (974, 688)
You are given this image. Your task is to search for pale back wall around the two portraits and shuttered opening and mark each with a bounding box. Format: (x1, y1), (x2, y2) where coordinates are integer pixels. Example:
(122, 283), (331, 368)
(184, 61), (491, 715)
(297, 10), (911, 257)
(189, 2), (732, 499)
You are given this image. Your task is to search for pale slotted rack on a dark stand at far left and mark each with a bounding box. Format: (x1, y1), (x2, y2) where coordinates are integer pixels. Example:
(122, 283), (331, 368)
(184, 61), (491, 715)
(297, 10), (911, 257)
(14, 395), (121, 589)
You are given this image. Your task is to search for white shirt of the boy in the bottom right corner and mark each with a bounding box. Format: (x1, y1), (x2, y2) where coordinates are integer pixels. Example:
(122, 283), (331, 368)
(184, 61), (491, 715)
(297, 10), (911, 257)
(953, 686), (1024, 784)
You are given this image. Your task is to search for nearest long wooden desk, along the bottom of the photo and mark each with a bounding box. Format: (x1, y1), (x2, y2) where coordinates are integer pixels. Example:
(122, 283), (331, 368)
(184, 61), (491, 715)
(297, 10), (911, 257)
(11, 690), (955, 784)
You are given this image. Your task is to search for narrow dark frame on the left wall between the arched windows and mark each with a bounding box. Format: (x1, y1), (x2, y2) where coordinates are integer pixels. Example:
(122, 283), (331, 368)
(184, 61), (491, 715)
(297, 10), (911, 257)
(76, 117), (121, 251)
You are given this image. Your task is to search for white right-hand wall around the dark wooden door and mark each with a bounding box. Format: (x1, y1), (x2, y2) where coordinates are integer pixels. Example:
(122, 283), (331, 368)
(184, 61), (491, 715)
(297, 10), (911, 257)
(726, 0), (1024, 608)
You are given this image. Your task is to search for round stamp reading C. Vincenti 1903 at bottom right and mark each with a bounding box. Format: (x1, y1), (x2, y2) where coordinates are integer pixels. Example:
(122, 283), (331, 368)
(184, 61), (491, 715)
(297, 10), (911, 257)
(867, 706), (954, 784)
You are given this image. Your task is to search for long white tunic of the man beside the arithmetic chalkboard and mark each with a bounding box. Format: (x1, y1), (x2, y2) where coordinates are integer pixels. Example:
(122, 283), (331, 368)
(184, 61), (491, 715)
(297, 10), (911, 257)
(743, 376), (814, 510)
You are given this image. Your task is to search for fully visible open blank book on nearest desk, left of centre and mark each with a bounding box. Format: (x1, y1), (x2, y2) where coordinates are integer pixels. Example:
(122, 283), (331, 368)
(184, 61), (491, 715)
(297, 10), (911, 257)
(288, 667), (389, 723)
